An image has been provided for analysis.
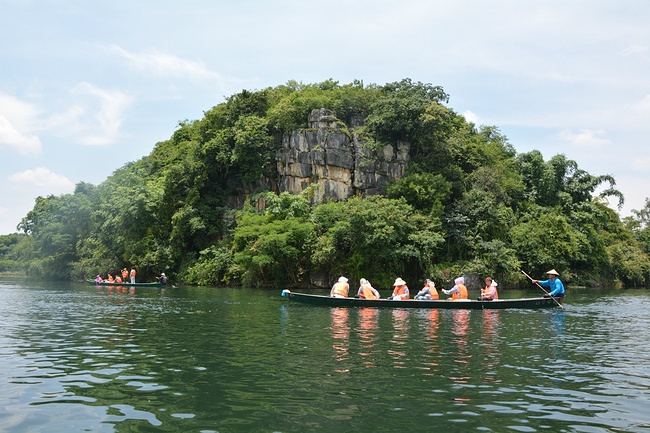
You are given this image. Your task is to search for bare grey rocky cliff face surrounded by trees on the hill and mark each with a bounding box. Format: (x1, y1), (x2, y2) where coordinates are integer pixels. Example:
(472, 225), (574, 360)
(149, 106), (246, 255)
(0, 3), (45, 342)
(276, 108), (409, 201)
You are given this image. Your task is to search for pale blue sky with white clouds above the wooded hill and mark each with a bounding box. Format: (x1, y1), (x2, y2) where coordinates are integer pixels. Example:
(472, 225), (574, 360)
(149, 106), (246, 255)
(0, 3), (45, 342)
(0, 0), (650, 235)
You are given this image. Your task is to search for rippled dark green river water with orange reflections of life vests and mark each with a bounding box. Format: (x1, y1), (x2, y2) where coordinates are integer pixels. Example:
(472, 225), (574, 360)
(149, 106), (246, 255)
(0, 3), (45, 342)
(0, 277), (650, 433)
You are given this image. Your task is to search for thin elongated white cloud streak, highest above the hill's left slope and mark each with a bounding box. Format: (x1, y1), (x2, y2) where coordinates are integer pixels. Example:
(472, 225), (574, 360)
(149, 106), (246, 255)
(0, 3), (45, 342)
(108, 45), (222, 85)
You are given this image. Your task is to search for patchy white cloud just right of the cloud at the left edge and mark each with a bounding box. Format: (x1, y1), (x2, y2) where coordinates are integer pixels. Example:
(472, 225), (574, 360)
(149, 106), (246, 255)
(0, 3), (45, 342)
(47, 82), (133, 145)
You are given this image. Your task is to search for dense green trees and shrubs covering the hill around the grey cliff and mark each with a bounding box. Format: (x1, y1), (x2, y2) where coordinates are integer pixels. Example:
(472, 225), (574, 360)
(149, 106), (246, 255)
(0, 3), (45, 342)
(0, 79), (650, 290)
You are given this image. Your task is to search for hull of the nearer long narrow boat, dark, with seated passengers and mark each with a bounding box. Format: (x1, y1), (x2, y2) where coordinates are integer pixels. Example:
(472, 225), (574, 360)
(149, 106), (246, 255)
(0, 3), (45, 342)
(282, 290), (559, 310)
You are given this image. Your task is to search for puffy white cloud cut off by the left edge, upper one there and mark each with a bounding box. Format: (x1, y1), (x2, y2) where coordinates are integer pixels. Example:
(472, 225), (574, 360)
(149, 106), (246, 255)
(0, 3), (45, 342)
(0, 93), (42, 155)
